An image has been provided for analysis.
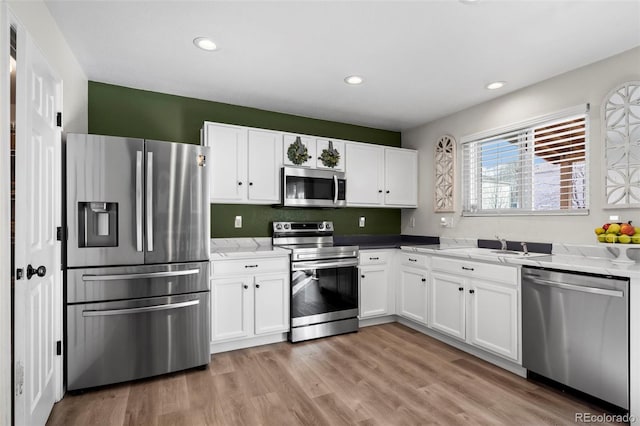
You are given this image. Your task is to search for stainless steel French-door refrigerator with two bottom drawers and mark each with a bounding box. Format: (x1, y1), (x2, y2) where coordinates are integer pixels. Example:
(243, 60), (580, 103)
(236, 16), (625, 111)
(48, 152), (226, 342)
(65, 134), (210, 390)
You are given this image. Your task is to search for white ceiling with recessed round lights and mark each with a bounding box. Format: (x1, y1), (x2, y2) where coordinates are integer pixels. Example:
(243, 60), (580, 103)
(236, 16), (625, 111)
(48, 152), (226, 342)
(47, 0), (640, 130)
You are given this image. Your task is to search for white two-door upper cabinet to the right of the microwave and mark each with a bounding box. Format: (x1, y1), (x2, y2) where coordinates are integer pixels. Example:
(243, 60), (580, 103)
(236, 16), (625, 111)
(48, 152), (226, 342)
(345, 142), (418, 207)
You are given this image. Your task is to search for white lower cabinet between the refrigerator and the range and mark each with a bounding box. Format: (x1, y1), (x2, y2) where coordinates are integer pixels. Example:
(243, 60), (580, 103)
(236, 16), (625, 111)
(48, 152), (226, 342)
(211, 257), (290, 343)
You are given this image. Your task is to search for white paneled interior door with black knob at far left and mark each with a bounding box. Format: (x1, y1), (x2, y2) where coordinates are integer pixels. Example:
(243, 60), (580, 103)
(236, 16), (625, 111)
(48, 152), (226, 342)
(14, 27), (62, 425)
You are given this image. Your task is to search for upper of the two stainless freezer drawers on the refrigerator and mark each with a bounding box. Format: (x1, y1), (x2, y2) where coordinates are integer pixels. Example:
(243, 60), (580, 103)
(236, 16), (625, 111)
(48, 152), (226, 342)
(67, 262), (209, 304)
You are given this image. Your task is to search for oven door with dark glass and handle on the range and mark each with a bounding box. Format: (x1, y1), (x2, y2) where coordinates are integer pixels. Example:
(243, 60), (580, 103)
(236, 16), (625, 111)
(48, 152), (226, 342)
(291, 258), (358, 327)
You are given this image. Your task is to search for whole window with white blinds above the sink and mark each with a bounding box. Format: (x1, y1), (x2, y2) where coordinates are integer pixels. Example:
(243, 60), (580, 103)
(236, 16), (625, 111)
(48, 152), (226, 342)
(462, 105), (589, 216)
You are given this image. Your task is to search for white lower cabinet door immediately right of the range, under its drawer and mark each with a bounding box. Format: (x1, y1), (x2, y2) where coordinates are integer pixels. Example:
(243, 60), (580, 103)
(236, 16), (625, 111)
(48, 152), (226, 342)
(360, 265), (389, 318)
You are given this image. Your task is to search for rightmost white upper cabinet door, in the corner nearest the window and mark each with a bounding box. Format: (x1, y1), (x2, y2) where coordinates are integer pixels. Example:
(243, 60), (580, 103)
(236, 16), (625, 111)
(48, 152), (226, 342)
(384, 148), (418, 207)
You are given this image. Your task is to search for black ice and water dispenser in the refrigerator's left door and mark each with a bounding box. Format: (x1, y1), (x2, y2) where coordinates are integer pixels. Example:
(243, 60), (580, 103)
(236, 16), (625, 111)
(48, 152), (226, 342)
(78, 201), (118, 247)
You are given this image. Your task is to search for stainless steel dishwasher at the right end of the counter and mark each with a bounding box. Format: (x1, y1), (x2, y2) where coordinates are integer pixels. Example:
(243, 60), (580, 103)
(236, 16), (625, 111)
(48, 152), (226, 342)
(522, 266), (629, 409)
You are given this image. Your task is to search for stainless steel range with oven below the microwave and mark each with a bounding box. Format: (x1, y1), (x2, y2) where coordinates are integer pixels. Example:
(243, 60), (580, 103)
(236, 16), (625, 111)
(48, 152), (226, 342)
(273, 222), (358, 342)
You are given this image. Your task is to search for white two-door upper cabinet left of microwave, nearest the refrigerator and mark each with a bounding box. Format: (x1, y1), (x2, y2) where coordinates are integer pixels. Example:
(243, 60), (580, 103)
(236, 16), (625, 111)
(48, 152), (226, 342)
(203, 122), (282, 204)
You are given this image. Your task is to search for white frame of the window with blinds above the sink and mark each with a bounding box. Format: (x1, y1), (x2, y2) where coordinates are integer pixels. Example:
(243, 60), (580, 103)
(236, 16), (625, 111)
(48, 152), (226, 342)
(460, 104), (591, 217)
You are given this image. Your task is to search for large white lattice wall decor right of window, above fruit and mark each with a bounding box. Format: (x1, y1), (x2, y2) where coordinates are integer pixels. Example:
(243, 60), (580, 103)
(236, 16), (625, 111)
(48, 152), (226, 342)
(602, 81), (640, 208)
